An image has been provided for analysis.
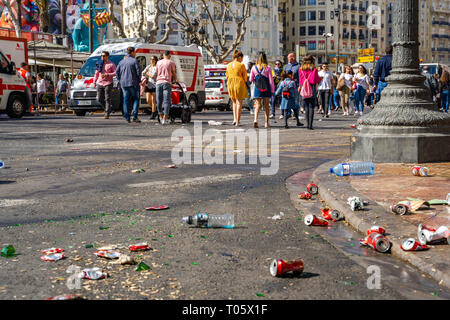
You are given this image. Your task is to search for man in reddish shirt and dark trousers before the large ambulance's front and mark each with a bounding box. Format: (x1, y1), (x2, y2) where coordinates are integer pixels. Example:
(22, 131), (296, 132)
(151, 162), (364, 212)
(94, 51), (117, 119)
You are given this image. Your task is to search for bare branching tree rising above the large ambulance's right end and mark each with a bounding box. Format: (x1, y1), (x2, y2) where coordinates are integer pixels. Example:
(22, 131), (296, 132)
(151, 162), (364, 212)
(162, 0), (251, 63)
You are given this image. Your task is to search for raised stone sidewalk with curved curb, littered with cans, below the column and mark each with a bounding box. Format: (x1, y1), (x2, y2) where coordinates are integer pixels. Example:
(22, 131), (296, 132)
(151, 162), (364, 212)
(312, 161), (450, 288)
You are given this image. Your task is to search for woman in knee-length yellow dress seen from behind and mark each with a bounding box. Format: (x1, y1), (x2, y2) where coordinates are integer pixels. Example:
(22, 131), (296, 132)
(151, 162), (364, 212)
(226, 50), (248, 126)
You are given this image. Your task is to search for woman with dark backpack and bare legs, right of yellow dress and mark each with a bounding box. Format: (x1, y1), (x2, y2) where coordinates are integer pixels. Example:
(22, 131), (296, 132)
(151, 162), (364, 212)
(250, 52), (275, 128)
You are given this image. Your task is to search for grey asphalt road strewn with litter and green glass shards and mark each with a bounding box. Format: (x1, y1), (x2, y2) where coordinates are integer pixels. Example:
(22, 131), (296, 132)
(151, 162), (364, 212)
(0, 111), (444, 300)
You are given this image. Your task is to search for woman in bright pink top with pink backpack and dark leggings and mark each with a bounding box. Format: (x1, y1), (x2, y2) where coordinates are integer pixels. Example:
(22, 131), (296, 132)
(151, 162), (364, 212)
(298, 55), (320, 130)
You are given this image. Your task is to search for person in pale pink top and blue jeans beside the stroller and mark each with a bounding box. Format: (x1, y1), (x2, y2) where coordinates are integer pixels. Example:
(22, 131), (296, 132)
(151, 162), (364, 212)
(156, 51), (177, 124)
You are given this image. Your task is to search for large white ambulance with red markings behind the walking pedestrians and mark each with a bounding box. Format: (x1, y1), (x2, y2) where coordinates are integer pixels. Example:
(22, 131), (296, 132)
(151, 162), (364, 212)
(67, 39), (205, 116)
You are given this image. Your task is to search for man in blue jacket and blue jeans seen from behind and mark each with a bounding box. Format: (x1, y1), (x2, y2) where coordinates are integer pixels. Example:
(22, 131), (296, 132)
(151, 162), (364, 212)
(116, 47), (141, 123)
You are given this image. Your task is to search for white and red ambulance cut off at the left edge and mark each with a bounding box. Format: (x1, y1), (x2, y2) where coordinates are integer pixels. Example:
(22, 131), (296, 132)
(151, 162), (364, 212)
(0, 37), (31, 118)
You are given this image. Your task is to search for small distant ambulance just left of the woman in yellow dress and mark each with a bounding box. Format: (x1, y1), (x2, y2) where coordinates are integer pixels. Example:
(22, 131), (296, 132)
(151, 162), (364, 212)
(205, 64), (233, 111)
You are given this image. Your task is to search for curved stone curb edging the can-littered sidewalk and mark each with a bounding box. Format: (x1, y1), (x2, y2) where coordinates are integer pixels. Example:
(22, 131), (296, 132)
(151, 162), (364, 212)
(312, 161), (450, 288)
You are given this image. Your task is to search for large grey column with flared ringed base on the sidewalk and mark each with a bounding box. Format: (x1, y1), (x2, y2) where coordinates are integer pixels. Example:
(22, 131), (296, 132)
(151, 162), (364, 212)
(350, 0), (450, 163)
